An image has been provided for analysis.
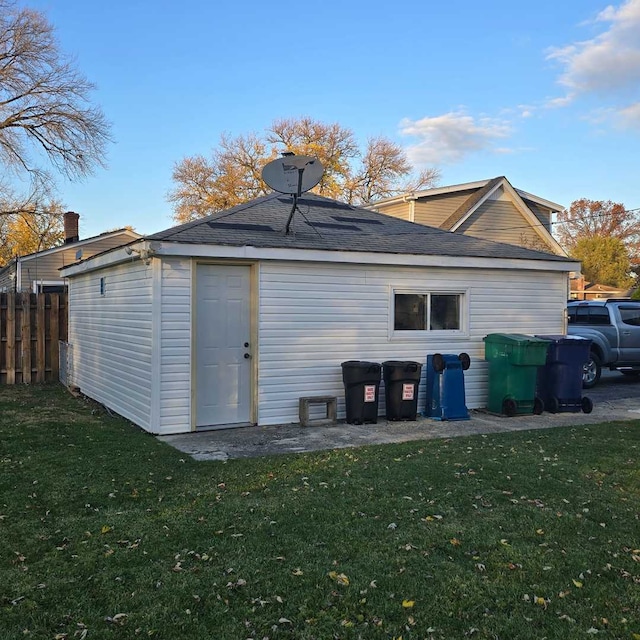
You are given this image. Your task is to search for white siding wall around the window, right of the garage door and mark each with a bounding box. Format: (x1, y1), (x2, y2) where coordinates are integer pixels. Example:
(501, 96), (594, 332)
(258, 262), (567, 425)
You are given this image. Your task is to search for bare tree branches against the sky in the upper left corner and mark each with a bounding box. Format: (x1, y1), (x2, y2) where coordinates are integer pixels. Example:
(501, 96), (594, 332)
(0, 0), (110, 179)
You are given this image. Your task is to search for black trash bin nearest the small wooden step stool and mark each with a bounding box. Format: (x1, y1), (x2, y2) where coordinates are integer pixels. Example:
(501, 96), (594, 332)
(342, 360), (381, 424)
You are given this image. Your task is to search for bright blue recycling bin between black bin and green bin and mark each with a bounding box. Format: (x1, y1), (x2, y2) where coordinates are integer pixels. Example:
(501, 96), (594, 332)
(424, 353), (471, 420)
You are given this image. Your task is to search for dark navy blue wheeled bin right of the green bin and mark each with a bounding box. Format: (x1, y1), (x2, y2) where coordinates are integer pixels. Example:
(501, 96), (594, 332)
(536, 335), (593, 413)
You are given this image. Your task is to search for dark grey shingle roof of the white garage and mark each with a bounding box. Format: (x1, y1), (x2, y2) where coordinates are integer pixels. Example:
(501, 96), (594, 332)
(147, 193), (569, 262)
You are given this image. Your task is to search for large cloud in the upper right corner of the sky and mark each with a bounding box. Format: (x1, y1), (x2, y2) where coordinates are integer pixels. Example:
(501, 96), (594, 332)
(547, 0), (640, 97)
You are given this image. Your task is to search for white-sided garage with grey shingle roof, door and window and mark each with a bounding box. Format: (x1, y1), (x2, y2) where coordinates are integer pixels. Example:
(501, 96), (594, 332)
(63, 193), (579, 434)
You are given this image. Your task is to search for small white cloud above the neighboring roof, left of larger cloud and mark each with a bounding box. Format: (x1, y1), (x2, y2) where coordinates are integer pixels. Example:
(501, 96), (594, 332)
(400, 111), (511, 165)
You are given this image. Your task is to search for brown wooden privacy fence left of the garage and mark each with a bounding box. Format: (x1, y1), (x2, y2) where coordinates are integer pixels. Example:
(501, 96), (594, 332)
(0, 293), (67, 384)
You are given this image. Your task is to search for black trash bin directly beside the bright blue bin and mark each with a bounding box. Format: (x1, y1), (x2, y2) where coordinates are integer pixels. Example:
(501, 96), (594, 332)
(382, 360), (422, 420)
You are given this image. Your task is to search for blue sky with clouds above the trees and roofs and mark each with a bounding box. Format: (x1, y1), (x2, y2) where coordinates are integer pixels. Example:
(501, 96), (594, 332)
(22, 0), (640, 237)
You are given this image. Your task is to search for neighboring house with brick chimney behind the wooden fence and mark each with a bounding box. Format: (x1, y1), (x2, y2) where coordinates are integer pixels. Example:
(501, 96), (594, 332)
(0, 211), (141, 293)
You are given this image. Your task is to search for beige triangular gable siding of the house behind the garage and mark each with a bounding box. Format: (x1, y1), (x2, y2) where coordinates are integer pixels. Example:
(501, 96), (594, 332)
(456, 200), (553, 253)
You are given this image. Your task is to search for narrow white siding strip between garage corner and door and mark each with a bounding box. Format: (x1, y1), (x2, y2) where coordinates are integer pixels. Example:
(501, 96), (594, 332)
(159, 258), (192, 433)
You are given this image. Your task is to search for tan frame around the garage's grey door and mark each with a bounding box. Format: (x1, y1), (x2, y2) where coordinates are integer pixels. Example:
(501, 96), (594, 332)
(190, 258), (260, 431)
